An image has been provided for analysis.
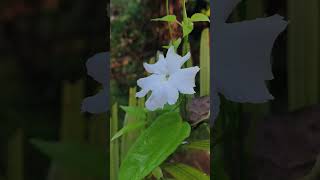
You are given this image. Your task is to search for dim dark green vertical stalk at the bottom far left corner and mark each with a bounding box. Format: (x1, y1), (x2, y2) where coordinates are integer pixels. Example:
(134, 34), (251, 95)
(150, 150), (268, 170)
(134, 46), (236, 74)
(7, 128), (24, 180)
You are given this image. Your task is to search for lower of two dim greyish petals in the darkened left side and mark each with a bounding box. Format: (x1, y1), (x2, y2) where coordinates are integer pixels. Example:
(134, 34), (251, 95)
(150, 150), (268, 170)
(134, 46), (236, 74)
(81, 88), (108, 114)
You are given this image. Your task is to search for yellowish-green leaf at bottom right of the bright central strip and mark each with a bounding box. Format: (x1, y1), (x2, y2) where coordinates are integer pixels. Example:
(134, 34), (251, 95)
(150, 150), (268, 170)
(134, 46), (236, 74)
(164, 163), (210, 180)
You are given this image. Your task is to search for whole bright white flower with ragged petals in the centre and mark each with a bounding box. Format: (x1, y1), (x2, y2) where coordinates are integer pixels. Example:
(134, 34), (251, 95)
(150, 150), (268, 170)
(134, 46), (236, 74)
(136, 46), (200, 111)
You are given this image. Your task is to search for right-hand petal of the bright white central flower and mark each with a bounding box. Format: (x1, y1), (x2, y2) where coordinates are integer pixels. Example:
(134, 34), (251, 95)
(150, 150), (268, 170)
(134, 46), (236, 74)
(169, 66), (200, 94)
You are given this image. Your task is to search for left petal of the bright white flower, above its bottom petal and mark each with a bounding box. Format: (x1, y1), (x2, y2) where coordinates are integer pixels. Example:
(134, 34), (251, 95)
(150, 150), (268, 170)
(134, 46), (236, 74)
(136, 74), (165, 97)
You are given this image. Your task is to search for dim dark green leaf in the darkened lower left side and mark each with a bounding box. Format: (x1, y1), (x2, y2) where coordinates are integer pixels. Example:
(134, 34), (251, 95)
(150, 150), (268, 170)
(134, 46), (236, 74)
(30, 139), (108, 177)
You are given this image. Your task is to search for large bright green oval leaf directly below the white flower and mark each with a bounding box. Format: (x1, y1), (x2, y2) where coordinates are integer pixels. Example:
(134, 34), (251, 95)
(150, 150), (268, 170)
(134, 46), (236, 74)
(119, 112), (191, 180)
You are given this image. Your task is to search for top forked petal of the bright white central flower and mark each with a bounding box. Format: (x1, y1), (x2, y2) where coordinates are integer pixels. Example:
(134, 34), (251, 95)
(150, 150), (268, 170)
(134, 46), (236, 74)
(166, 46), (191, 74)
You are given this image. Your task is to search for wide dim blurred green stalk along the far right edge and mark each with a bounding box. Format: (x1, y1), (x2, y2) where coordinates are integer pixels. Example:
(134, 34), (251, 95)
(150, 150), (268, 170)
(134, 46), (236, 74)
(288, 0), (320, 110)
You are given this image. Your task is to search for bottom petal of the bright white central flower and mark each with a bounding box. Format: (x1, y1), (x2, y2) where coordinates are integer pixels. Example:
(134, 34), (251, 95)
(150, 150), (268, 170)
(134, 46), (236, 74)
(146, 87), (167, 111)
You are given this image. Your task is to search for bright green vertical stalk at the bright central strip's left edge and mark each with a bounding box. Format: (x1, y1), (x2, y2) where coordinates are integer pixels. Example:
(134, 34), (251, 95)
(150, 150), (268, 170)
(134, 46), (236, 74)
(110, 103), (120, 180)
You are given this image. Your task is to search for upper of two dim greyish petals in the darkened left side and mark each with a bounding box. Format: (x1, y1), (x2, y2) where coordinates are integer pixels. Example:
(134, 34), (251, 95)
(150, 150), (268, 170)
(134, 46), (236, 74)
(86, 52), (109, 85)
